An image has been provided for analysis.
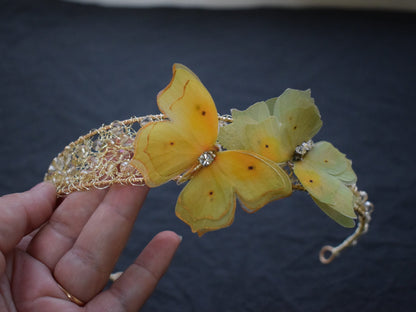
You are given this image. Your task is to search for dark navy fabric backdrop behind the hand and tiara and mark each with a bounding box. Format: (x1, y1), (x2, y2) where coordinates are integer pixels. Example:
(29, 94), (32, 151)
(0, 1), (416, 312)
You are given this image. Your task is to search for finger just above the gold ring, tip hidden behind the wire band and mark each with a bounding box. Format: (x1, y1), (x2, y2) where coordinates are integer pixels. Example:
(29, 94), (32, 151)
(54, 185), (148, 302)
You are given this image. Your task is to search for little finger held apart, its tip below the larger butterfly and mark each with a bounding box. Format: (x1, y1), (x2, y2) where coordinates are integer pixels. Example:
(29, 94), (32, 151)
(87, 231), (182, 311)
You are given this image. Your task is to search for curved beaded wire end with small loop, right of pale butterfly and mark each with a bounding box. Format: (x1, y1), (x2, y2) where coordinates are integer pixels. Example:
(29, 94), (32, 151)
(319, 185), (374, 264)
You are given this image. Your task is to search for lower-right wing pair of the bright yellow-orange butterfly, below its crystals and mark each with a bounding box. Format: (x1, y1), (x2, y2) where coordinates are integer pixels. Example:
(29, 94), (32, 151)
(176, 151), (292, 235)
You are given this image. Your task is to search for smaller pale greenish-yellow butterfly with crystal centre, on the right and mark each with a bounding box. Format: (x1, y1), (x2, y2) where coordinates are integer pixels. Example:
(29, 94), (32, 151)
(219, 89), (357, 227)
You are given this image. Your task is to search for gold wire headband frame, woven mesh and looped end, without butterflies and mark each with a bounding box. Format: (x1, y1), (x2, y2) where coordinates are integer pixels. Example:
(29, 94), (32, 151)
(45, 114), (374, 264)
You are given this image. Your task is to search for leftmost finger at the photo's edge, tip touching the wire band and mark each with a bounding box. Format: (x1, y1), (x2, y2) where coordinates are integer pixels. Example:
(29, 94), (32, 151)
(0, 182), (56, 273)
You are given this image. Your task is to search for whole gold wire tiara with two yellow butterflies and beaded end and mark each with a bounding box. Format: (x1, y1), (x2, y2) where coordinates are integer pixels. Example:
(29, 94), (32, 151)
(45, 64), (374, 263)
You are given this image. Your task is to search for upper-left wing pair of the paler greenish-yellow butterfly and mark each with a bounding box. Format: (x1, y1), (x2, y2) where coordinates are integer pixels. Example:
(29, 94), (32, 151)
(219, 89), (322, 163)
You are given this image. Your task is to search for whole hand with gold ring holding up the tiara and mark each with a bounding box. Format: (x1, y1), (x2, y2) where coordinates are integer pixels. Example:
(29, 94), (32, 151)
(0, 183), (181, 312)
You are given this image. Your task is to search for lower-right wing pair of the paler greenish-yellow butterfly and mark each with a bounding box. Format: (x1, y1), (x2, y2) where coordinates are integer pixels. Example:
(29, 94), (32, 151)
(294, 142), (356, 227)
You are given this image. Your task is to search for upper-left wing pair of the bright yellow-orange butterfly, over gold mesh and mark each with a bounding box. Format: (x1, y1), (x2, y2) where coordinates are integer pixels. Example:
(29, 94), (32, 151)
(131, 64), (218, 187)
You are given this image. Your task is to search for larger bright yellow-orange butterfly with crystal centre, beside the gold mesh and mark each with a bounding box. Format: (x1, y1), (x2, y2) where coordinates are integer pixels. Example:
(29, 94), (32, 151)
(132, 64), (292, 235)
